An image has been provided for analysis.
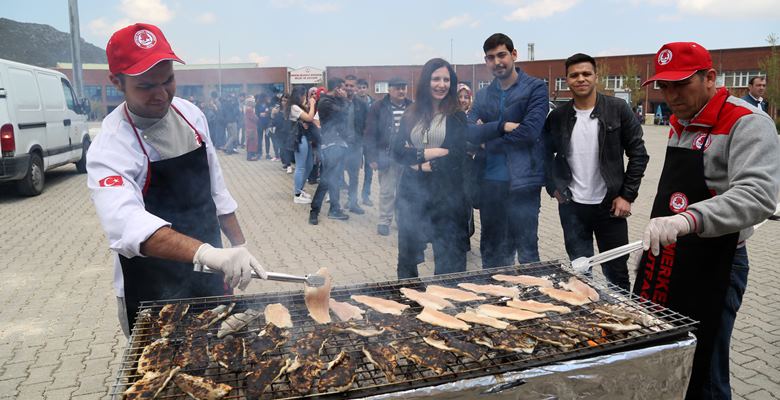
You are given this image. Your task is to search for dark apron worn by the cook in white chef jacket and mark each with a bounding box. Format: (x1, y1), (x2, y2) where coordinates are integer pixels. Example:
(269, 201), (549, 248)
(119, 105), (228, 331)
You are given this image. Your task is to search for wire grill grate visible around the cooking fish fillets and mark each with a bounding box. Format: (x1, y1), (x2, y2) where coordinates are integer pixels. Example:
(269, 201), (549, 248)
(111, 261), (696, 399)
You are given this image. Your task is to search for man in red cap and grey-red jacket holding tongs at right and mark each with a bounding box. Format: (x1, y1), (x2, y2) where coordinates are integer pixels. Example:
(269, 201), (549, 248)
(634, 42), (780, 399)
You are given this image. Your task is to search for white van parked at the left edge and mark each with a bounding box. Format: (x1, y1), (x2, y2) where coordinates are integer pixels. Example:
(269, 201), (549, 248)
(0, 59), (90, 196)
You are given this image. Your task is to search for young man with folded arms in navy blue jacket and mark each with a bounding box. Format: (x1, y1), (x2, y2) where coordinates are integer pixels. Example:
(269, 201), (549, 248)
(468, 33), (550, 268)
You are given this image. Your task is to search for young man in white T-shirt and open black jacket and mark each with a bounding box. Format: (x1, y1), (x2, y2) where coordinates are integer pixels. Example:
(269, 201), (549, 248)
(544, 53), (650, 290)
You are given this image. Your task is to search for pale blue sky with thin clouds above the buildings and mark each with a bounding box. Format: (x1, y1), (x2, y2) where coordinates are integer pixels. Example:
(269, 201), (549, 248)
(0, 0), (780, 68)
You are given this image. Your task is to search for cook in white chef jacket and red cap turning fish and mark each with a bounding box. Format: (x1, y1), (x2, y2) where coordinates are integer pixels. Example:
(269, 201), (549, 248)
(87, 24), (266, 335)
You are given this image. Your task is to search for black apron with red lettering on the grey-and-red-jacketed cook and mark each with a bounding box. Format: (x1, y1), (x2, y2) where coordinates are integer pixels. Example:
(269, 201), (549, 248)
(634, 136), (739, 399)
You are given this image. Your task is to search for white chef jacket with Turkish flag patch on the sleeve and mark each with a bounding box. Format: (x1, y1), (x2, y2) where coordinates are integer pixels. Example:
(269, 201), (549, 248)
(87, 97), (238, 297)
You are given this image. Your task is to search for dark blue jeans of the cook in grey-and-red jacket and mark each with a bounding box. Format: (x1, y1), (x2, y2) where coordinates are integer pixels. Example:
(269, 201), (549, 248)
(703, 246), (749, 399)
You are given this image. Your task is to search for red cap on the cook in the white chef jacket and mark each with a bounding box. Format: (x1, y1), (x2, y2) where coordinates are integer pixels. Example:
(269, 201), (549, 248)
(106, 23), (184, 75)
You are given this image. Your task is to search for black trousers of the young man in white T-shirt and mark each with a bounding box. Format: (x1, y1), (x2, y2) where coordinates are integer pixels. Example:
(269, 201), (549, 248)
(558, 201), (630, 290)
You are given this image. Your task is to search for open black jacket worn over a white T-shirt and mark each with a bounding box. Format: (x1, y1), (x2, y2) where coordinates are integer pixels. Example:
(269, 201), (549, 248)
(543, 93), (650, 204)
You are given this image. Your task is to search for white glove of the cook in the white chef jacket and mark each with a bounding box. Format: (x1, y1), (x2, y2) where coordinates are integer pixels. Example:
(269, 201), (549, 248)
(192, 243), (268, 290)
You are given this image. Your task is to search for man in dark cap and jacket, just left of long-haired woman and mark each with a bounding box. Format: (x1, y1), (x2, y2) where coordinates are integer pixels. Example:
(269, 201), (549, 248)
(363, 78), (412, 236)
